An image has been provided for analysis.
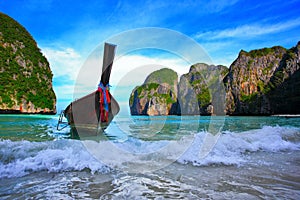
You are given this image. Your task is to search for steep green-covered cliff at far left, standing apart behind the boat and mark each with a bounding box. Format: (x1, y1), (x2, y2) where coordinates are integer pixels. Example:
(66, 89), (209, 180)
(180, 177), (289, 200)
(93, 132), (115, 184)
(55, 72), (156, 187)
(0, 13), (56, 114)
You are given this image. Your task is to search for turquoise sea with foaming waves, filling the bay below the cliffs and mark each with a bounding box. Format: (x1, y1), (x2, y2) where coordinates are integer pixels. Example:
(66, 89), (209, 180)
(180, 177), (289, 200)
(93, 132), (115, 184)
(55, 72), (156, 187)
(0, 115), (300, 199)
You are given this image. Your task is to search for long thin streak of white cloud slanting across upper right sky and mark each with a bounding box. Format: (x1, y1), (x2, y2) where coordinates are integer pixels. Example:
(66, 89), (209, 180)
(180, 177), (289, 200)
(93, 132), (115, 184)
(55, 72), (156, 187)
(195, 18), (300, 40)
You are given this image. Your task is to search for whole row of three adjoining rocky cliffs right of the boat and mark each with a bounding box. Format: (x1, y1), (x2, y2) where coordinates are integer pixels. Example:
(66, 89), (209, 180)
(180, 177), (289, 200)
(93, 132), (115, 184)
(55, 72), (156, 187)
(129, 42), (300, 116)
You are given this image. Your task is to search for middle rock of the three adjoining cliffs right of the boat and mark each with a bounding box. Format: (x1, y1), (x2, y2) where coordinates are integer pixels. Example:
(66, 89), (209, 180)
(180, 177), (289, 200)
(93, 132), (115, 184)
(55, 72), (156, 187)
(176, 63), (228, 115)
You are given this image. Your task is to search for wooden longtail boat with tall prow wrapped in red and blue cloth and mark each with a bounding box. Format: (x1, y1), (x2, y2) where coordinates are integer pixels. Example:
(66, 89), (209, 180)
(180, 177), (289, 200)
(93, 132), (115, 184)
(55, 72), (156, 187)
(57, 43), (120, 135)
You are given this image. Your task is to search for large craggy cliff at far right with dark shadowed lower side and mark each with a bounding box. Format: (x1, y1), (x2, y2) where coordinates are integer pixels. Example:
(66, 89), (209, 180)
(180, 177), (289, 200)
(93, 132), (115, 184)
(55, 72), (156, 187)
(224, 43), (300, 115)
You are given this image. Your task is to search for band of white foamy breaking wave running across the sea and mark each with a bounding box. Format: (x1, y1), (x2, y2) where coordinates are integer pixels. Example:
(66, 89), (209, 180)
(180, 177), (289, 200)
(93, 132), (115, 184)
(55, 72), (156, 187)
(0, 126), (300, 178)
